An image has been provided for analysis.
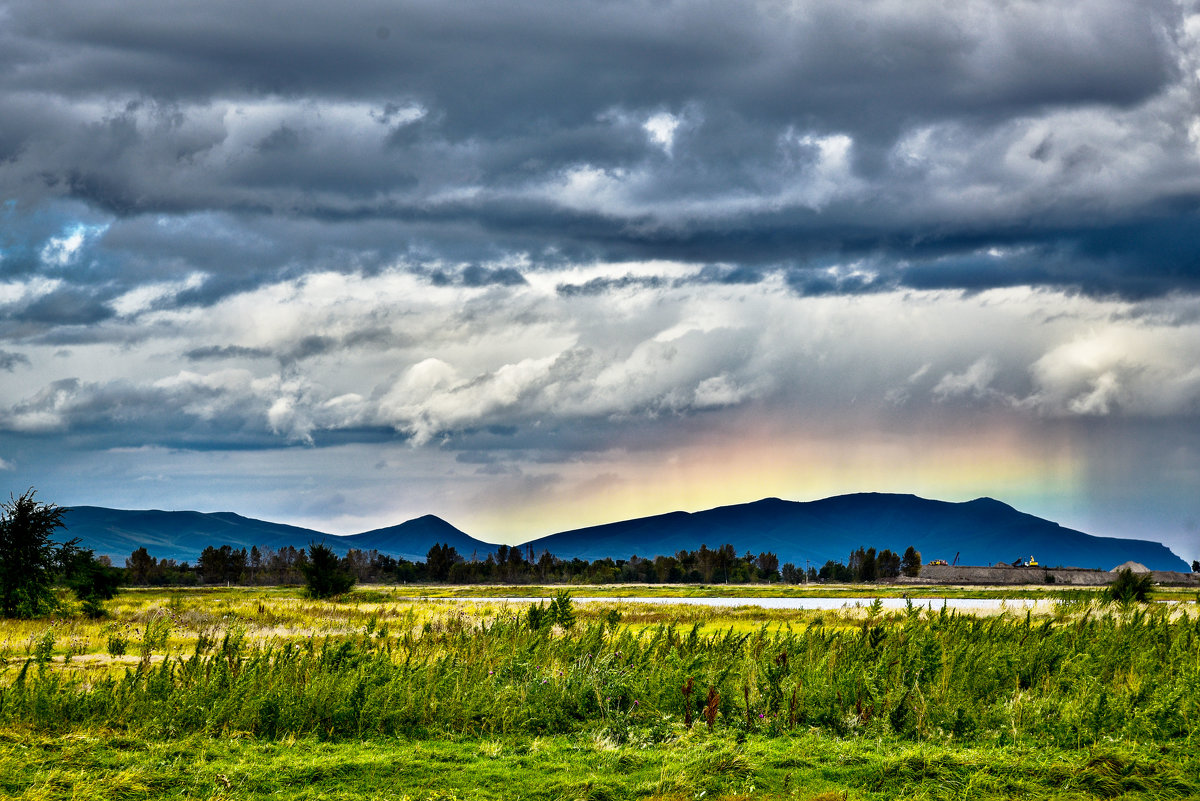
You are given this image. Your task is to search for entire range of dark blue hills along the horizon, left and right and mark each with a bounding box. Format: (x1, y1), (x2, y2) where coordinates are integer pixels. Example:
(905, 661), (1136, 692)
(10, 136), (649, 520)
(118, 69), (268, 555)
(64, 493), (1188, 572)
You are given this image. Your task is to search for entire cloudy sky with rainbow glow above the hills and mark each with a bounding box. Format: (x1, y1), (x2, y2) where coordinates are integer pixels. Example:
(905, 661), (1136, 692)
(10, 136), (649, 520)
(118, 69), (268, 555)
(0, 0), (1200, 560)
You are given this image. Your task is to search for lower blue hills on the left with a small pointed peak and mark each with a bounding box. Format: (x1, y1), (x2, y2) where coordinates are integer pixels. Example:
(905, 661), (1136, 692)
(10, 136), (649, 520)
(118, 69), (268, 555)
(60, 506), (496, 565)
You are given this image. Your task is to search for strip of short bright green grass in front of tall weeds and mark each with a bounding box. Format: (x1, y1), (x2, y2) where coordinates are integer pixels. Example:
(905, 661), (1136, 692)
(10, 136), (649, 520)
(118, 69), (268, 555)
(0, 731), (1200, 801)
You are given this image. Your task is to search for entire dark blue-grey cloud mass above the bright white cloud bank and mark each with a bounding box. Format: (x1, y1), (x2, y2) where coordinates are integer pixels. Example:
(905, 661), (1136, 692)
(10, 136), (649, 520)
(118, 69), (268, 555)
(0, 0), (1185, 303)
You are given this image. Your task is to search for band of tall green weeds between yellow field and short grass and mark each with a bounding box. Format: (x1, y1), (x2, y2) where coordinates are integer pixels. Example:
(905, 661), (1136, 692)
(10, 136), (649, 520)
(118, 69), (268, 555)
(0, 599), (1200, 747)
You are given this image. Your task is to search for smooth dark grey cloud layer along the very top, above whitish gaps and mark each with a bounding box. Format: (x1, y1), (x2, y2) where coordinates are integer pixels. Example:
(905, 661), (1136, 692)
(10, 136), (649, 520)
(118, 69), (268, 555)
(5, 0), (1178, 126)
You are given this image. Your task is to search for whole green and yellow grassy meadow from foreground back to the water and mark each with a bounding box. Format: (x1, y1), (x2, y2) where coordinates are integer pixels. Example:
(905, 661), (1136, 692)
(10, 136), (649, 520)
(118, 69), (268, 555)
(0, 586), (1200, 800)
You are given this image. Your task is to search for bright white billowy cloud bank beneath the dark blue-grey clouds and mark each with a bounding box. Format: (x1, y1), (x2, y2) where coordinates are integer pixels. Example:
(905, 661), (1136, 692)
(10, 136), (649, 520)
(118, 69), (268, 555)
(0, 265), (1200, 460)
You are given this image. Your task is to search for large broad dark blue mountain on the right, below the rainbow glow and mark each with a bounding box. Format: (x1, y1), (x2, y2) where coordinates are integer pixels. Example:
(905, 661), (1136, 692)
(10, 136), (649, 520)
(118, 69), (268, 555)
(520, 493), (1188, 572)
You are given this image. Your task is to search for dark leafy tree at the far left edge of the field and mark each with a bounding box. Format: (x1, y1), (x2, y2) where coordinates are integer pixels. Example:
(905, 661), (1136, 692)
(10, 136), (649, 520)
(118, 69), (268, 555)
(0, 488), (67, 618)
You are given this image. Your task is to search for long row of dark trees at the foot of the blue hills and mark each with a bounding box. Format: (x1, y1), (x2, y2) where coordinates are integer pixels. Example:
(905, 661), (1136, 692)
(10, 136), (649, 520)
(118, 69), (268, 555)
(125, 543), (922, 586)
